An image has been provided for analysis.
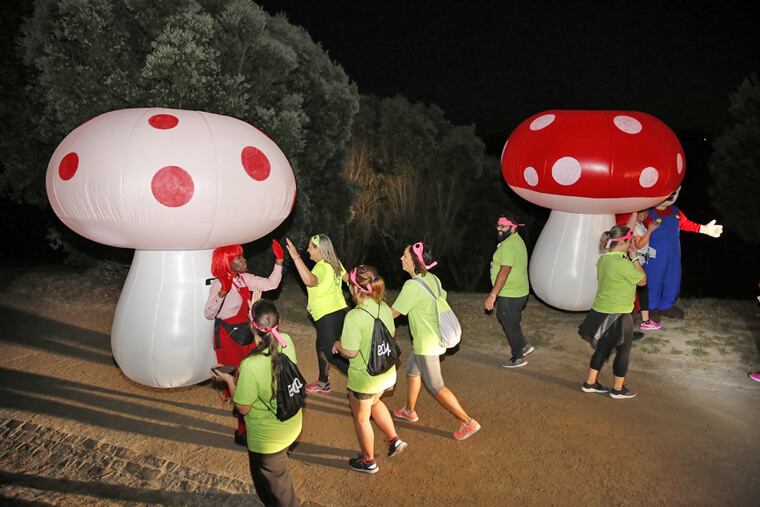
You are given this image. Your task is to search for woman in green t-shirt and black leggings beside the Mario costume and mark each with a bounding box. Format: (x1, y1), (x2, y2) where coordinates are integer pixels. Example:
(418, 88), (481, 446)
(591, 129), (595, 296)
(578, 225), (647, 399)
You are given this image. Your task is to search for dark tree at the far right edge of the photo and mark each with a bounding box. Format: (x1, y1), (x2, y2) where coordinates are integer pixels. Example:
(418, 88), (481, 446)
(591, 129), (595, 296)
(709, 73), (760, 243)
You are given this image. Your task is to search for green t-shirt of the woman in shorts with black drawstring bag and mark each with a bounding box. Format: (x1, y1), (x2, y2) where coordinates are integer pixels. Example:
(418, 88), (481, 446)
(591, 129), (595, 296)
(340, 299), (396, 394)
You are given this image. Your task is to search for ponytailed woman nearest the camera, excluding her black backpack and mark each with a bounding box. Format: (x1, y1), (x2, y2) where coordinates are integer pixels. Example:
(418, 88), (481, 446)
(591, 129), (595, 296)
(211, 299), (303, 506)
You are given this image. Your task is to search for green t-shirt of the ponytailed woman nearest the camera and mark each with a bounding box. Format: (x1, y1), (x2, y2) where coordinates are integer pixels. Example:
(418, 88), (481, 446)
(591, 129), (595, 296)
(232, 334), (303, 454)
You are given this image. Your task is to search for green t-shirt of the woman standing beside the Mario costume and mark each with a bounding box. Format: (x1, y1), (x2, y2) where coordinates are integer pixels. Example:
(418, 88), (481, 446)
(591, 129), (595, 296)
(591, 252), (644, 313)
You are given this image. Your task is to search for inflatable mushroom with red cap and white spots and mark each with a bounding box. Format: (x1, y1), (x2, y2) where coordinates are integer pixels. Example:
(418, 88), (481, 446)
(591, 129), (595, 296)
(501, 111), (684, 311)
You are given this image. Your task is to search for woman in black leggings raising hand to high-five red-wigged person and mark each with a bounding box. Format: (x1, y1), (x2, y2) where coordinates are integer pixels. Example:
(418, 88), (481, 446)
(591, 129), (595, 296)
(286, 234), (348, 394)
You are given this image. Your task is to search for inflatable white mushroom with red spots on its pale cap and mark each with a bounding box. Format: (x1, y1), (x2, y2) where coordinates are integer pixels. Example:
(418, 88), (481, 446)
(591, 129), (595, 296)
(46, 109), (296, 387)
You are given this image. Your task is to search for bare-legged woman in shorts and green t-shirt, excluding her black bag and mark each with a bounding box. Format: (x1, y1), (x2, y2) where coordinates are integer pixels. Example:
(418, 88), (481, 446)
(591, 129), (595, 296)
(333, 265), (406, 474)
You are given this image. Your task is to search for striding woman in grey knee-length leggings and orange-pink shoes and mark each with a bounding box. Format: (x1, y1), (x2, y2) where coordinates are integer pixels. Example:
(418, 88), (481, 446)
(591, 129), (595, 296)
(391, 242), (480, 440)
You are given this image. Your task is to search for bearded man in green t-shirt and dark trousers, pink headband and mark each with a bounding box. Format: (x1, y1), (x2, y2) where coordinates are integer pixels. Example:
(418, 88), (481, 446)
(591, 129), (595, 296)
(485, 213), (534, 368)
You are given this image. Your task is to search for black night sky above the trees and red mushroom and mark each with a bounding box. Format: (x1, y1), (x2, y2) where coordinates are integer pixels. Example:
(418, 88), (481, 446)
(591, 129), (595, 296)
(258, 0), (760, 151)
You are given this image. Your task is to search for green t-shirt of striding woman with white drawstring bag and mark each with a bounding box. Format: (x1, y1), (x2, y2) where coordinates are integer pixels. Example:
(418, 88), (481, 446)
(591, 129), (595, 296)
(393, 272), (446, 356)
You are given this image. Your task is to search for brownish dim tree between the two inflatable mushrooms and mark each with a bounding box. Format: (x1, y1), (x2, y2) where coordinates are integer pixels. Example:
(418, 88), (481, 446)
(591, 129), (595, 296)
(341, 96), (507, 290)
